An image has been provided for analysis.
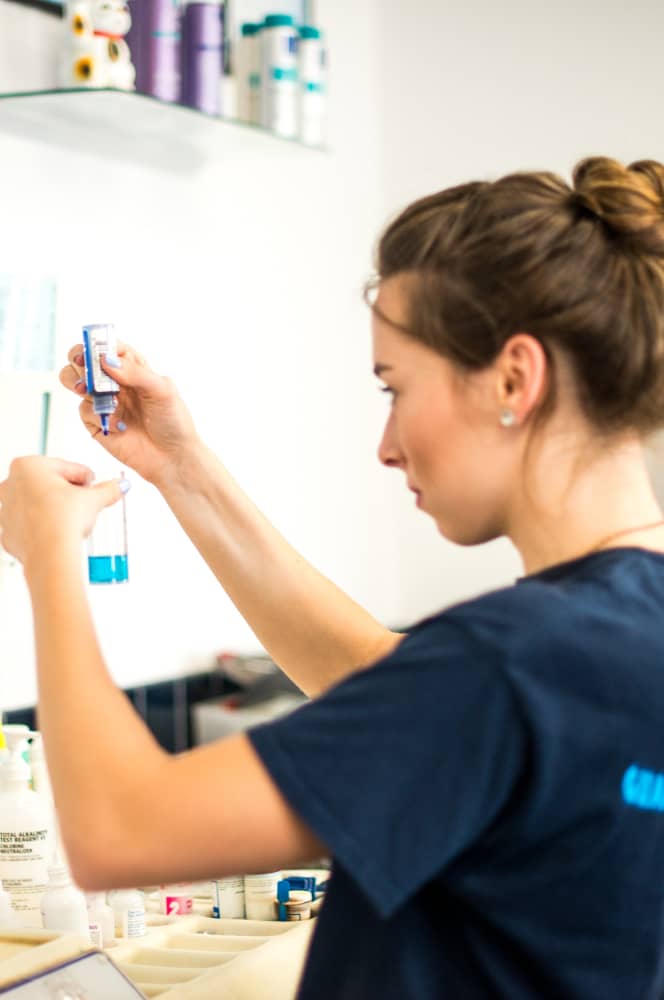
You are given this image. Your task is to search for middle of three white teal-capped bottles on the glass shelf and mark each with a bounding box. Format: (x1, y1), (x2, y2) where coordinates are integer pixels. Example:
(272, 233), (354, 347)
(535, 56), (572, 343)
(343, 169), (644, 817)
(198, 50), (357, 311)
(259, 14), (298, 139)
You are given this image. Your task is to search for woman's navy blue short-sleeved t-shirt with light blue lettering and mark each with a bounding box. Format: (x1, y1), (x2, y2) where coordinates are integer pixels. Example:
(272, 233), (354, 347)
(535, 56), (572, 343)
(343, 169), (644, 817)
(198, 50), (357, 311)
(250, 548), (664, 1000)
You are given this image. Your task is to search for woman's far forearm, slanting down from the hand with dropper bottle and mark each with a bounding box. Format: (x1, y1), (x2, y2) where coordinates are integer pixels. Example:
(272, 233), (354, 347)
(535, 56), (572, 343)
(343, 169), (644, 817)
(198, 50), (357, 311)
(156, 445), (400, 695)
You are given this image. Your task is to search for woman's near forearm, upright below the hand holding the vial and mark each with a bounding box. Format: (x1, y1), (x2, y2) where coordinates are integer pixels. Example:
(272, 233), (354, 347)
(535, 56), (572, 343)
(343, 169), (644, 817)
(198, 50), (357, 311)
(25, 544), (166, 882)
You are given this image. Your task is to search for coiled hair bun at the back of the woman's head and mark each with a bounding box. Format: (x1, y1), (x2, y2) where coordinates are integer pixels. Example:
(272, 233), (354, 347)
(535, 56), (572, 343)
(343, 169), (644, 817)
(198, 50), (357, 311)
(572, 156), (664, 257)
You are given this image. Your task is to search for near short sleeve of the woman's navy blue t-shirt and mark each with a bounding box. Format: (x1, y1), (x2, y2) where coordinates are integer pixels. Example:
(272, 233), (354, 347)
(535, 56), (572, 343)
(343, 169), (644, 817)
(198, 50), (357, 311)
(248, 617), (526, 917)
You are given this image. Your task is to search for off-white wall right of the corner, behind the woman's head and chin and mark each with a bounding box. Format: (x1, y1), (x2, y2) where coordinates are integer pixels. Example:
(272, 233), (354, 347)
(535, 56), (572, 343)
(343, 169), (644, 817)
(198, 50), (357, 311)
(370, 0), (664, 620)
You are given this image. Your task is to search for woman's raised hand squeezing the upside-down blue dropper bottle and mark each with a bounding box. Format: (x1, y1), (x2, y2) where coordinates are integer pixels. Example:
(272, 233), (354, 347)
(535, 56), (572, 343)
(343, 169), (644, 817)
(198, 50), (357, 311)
(60, 343), (198, 485)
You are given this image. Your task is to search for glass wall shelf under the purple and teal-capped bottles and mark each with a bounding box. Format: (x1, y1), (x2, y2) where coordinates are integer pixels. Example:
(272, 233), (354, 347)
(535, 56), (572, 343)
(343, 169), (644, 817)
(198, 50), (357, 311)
(0, 88), (323, 174)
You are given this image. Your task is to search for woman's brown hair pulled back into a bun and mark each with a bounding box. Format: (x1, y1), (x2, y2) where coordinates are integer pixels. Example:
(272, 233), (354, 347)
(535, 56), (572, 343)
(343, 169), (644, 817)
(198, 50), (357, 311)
(366, 157), (664, 434)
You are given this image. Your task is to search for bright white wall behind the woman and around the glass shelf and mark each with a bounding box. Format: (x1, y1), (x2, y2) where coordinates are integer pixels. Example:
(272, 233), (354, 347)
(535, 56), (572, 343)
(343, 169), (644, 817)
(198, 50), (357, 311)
(0, 0), (664, 708)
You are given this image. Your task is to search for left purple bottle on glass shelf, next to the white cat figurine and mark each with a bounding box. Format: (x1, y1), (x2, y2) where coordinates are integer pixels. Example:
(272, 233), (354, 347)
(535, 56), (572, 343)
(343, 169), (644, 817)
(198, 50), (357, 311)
(127, 0), (182, 101)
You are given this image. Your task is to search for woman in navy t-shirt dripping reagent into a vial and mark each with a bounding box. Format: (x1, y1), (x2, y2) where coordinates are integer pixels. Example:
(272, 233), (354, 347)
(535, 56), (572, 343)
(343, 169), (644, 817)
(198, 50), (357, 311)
(0, 158), (664, 1000)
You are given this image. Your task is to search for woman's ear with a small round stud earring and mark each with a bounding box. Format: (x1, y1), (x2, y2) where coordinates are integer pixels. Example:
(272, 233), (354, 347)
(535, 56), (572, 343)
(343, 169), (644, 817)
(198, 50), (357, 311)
(494, 333), (549, 426)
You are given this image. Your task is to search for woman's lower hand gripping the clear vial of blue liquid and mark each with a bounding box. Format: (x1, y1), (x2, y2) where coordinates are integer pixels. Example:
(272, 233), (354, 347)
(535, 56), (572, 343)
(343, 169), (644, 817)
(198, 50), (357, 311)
(0, 456), (126, 566)
